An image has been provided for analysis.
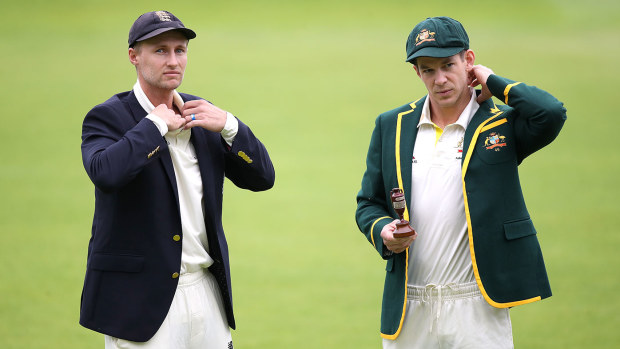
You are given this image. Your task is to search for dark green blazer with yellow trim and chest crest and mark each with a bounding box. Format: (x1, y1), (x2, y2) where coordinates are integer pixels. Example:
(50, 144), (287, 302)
(355, 75), (566, 339)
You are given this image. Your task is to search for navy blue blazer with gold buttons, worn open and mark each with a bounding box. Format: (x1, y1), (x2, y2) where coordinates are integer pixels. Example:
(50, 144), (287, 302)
(80, 91), (275, 342)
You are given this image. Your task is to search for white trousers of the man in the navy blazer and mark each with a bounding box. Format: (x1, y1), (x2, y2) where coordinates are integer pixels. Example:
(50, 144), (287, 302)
(105, 269), (233, 349)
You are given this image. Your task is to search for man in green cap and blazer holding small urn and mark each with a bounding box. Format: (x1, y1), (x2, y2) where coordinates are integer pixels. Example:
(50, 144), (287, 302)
(356, 17), (566, 349)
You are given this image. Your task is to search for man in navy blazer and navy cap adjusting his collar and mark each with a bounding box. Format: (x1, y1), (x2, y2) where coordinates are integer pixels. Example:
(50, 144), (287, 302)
(80, 11), (275, 348)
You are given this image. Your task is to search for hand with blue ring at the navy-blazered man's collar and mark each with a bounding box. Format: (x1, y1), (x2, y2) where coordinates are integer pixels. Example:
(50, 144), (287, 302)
(181, 99), (227, 132)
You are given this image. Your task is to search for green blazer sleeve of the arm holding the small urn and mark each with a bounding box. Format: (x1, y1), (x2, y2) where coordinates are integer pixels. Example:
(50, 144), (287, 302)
(355, 116), (394, 259)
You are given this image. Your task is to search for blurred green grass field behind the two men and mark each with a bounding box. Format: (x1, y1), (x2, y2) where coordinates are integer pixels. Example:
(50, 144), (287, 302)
(0, 0), (620, 349)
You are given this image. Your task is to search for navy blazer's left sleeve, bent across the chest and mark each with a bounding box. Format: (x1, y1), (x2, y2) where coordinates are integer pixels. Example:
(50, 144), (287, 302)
(82, 104), (167, 191)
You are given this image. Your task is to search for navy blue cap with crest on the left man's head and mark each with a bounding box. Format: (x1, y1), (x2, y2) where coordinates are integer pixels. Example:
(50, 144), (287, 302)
(128, 11), (196, 47)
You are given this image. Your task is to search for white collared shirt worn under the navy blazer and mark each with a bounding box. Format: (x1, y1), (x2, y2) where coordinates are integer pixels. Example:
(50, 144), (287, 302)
(133, 81), (238, 274)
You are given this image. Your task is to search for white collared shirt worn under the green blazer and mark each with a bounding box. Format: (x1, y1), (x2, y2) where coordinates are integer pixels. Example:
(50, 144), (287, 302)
(408, 89), (479, 286)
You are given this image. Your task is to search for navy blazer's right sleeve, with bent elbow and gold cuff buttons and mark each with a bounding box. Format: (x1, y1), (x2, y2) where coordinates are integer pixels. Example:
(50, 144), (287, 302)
(225, 120), (276, 191)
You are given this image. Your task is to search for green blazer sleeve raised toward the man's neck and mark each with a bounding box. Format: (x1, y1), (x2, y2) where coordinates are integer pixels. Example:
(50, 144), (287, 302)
(487, 75), (566, 163)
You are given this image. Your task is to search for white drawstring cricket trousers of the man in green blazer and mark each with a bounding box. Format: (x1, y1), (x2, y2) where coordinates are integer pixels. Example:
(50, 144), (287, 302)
(383, 282), (514, 349)
